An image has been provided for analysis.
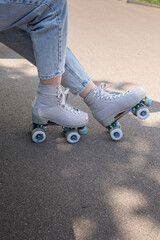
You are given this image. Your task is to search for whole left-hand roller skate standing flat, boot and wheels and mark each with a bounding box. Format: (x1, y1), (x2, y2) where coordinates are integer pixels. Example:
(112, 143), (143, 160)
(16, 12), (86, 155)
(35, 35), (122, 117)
(30, 84), (88, 143)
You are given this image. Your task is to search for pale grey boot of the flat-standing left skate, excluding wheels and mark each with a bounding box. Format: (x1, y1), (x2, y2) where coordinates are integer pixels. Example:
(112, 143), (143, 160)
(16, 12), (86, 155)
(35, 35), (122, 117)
(32, 84), (88, 128)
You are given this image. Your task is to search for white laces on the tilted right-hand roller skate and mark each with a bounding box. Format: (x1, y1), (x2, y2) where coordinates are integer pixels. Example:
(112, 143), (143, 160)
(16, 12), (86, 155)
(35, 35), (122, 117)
(94, 83), (130, 100)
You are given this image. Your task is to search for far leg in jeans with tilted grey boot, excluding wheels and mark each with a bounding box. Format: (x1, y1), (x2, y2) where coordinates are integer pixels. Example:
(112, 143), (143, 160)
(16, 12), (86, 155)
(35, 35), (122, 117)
(0, 24), (145, 129)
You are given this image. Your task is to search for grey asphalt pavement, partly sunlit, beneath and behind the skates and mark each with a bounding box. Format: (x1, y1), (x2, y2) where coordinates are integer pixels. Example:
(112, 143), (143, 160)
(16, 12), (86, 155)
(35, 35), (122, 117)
(0, 0), (160, 240)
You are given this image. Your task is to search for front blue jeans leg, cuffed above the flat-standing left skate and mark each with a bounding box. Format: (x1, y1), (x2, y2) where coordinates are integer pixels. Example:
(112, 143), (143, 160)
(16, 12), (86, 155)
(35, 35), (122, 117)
(0, 0), (68, 79)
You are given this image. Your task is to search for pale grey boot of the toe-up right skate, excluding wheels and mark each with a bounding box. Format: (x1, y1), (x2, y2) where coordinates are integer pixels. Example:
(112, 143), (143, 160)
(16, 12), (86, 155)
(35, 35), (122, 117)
(84, 84), (145, 127)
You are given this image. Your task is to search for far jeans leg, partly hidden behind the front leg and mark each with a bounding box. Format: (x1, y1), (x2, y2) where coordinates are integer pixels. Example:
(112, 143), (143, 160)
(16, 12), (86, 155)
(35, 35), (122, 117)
(0, 27), (93, 95)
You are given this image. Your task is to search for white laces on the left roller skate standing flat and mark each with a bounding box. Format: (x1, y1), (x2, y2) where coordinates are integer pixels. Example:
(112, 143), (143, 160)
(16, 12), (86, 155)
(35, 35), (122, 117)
(56, 86), (80, 114)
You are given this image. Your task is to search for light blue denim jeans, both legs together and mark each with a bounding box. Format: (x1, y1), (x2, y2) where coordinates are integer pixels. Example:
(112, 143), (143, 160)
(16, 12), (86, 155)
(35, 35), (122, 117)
(0, 0), (90, 94)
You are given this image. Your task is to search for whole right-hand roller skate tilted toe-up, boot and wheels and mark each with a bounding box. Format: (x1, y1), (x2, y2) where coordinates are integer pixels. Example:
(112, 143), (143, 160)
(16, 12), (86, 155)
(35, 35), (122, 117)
(84, 83), (152, 141)
